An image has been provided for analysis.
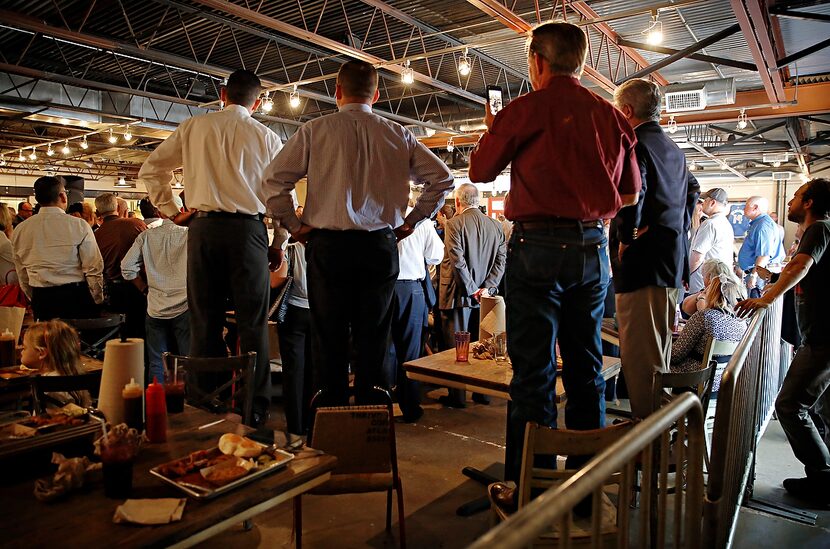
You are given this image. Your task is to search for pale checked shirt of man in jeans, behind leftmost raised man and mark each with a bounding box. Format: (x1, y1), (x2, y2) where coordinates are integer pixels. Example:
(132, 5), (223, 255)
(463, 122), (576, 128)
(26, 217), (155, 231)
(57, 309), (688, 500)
(121, 219), (187, 319)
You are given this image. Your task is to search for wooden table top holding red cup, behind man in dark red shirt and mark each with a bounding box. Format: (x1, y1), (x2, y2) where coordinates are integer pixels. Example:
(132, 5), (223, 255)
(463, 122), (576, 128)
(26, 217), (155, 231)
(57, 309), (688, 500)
(403, 349), (620, 403)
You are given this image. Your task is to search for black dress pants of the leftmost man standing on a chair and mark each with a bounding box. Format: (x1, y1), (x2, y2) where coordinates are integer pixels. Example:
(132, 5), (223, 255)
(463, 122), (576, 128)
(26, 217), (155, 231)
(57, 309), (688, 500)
(187, 216), (271, 412)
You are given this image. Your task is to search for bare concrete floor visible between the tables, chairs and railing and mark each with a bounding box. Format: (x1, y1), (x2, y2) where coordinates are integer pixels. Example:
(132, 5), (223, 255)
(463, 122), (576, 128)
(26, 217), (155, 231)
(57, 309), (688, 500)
(202, 389), (830, 549)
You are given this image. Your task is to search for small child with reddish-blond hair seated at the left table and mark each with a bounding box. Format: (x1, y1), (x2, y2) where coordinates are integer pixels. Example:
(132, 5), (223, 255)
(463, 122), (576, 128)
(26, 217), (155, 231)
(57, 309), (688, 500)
(20, 320), (92, 407)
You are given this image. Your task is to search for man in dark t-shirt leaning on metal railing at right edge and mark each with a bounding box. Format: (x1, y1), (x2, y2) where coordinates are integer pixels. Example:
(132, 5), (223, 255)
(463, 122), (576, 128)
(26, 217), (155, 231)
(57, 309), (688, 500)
(737, 179), (830, 505)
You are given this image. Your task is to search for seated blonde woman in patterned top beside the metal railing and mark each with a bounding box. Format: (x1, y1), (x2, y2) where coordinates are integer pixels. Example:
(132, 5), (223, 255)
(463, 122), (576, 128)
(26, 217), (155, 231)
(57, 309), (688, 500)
(669, 259), (747, 392)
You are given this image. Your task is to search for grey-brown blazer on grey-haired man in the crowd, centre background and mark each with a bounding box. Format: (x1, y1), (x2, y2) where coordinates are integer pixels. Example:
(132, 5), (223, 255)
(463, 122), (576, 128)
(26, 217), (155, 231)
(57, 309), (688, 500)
(438, 208), (507, 310)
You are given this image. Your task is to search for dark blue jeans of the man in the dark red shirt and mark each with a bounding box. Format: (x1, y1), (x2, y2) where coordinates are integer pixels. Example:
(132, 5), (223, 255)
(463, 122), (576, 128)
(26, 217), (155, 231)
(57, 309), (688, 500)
(505, 222), (609, 481)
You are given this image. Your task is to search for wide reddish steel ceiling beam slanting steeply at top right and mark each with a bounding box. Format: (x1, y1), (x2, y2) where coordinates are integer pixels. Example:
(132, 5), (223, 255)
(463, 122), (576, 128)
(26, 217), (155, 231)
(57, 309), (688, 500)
(730, 0), (785, 103)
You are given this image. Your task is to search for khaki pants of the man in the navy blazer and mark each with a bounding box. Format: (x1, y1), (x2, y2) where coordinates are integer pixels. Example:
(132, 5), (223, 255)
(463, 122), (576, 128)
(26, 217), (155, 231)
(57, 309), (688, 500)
(617, 286), (679, 418)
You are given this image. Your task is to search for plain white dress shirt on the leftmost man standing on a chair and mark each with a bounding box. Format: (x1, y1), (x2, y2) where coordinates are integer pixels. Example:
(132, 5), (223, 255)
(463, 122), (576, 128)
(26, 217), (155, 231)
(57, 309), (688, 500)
(138, 105), (282, 217)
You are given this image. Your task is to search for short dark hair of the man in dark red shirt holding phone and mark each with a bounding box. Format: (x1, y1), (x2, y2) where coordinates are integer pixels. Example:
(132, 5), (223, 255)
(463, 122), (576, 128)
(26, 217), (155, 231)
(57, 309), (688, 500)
(528, 22), (588, 76)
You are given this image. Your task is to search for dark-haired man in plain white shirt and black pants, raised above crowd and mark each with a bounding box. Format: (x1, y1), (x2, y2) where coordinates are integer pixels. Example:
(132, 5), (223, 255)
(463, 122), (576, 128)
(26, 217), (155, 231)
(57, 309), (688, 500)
(138, 70), (287, 426)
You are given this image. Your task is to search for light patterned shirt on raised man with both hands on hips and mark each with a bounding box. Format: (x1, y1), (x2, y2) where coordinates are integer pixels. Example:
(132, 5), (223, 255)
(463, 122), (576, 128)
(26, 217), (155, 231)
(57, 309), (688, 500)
(264, 103), (453, 232)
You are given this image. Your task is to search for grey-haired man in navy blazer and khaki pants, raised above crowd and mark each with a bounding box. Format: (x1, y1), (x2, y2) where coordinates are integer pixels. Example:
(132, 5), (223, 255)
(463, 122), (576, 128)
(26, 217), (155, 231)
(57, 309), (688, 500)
(614, 78), (700, 418)
